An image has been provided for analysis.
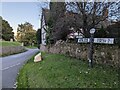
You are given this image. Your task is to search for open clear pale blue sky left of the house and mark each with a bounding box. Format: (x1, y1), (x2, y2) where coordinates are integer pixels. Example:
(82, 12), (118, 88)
(0, 2), (41, 32)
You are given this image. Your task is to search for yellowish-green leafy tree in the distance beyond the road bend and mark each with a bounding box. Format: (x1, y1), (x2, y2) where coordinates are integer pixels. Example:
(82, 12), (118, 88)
(16, 22), (36, 45)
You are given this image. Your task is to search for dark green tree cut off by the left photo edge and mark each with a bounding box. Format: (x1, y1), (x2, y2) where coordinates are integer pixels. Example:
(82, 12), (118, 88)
(0, 16), (14, 41)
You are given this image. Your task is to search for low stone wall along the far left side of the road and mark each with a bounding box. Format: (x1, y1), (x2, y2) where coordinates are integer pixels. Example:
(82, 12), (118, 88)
(0, 46), (26, 56)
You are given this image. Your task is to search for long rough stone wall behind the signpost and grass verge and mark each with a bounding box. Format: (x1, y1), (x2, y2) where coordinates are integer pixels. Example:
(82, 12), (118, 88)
(42, 40), (120, 67)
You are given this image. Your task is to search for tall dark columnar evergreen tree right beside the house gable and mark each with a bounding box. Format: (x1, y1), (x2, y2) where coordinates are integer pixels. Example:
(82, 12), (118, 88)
(48, 0), (66, 41)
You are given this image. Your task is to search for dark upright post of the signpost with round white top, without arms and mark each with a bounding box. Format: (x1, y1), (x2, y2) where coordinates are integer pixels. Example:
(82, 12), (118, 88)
(88, 28), (95, 68)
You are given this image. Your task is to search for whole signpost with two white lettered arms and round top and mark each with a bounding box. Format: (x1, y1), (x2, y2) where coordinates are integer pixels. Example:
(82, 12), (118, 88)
(78, 28), (114, 68)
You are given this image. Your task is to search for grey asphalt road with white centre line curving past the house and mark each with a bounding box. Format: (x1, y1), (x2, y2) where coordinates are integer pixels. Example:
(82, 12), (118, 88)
(0, 49), (39, 88)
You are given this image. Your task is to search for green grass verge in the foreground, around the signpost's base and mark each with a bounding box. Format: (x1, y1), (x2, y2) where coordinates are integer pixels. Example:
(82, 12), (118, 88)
(17, 53), (119, 88)
